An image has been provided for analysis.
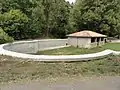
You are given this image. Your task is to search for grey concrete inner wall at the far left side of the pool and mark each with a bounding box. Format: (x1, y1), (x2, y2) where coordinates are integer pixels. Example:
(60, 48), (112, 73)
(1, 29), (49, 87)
(3, 39), (68, 53)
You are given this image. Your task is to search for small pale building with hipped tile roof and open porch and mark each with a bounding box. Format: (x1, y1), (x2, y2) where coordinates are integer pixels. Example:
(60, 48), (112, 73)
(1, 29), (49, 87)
(67, 30), (107, 48)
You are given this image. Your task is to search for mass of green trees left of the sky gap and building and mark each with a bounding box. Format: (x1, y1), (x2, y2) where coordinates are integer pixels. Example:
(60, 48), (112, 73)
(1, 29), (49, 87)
(0, 0), (72, 39)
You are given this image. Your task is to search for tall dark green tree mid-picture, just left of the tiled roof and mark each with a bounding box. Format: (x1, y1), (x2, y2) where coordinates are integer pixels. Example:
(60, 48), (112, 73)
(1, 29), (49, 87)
(42, 0), (71, 38)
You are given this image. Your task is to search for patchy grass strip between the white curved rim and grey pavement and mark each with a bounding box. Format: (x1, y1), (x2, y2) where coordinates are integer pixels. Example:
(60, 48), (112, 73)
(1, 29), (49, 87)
(0, 56), (120, 83)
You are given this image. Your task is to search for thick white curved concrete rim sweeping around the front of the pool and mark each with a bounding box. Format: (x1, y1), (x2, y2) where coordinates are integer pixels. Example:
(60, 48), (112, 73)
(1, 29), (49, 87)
(0, 40), (120, 62)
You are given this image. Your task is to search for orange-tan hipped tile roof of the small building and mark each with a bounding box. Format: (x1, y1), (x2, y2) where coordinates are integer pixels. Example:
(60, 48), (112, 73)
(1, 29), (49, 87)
(67, 30), (107, 37)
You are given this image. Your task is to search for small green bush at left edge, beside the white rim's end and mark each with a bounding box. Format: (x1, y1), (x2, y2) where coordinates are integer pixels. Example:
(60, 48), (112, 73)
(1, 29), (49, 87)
(0, 28), (14, 44)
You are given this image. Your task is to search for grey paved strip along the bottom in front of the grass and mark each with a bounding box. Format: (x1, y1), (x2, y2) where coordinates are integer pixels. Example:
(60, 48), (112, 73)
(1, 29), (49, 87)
(1, 77), (120, 90)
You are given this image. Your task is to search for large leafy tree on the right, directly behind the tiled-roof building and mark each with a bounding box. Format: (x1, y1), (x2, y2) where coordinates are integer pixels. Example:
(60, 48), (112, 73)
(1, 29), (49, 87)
(72, 0), (120, 36)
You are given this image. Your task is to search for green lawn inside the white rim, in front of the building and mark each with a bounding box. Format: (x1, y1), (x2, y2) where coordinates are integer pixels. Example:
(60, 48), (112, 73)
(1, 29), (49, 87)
(36, 43), (120, 55)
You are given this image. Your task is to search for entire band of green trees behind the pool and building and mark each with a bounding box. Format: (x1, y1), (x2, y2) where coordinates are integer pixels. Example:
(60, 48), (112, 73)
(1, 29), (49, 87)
(0, 0), (120, 43)
